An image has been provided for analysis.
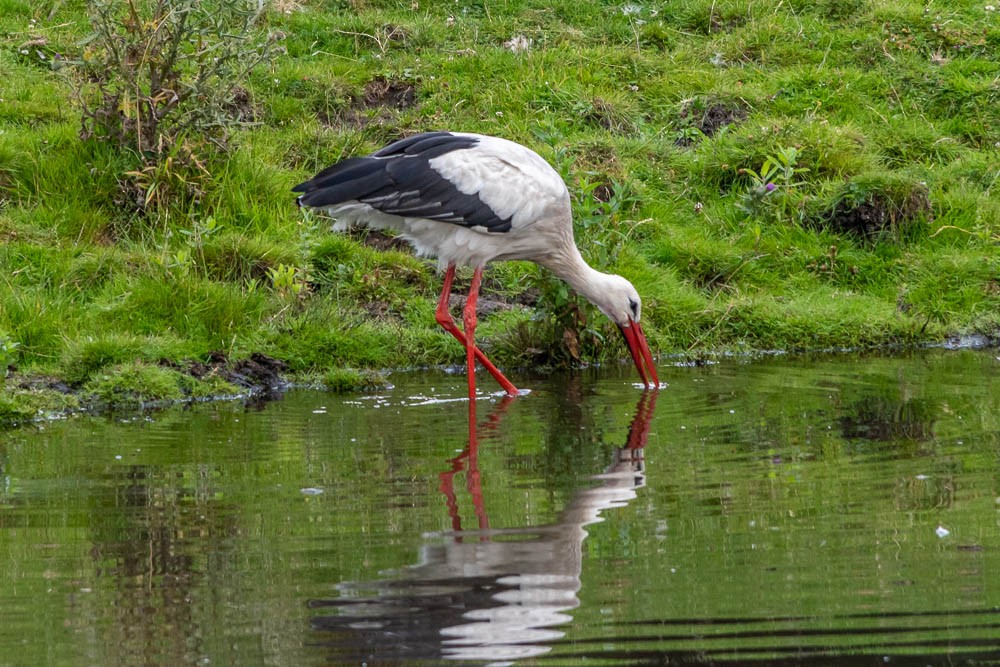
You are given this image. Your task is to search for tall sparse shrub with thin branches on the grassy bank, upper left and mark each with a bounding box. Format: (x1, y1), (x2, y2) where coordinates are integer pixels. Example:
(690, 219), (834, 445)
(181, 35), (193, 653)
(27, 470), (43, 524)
(71, 0), (281, 217)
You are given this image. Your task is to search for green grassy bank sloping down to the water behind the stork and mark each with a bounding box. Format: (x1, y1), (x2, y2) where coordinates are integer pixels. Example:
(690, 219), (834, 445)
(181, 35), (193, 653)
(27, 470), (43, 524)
(0, 0), (1000, 415)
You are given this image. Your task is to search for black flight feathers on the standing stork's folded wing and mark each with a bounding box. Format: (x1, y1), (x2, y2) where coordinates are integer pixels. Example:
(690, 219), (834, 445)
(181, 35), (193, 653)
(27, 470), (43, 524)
(293, 132), (510, 232)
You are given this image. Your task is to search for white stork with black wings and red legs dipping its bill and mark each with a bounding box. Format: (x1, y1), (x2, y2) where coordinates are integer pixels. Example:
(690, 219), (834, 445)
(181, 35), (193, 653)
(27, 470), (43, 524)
(293, 132), (659, 401)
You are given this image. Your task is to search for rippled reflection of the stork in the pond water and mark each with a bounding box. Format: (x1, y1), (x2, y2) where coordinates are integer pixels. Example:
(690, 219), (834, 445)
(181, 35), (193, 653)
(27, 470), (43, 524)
(309, 391), (657, 665)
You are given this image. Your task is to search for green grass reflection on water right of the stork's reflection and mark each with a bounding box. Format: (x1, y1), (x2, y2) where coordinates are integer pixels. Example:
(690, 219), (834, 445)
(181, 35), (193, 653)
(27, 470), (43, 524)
(567, 352), (1000, 664)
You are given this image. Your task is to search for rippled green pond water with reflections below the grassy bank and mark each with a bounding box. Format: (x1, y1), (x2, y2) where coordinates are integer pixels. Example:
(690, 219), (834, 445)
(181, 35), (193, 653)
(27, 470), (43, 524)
(0, 350), (1000, 665)
